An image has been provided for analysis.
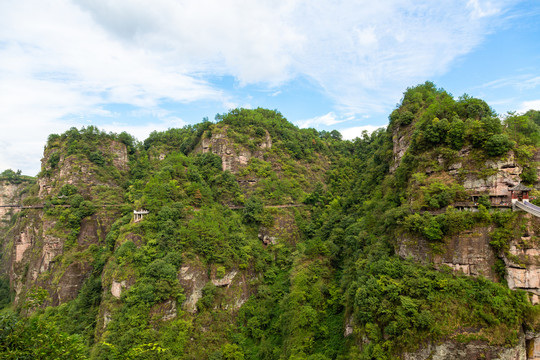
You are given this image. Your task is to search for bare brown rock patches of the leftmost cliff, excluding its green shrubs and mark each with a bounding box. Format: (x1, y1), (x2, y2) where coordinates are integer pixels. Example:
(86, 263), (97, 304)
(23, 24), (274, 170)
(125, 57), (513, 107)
(0, 140), (128, 305)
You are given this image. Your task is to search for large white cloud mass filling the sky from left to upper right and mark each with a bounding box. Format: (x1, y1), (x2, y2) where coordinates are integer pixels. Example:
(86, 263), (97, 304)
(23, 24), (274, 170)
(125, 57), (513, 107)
(0, 0), (507, 171)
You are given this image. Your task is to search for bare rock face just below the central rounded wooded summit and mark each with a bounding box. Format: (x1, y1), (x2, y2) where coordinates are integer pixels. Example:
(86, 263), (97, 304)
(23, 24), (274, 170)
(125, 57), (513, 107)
(195, 126), (272, 174)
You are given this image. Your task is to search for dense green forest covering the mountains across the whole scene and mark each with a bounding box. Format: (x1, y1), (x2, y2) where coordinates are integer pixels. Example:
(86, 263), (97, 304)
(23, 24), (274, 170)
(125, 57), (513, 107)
(0, 82), (540, 360)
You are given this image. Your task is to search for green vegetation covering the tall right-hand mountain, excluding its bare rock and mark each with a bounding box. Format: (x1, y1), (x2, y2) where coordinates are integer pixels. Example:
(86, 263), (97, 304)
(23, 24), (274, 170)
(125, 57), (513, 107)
(288, 83), (538, 358)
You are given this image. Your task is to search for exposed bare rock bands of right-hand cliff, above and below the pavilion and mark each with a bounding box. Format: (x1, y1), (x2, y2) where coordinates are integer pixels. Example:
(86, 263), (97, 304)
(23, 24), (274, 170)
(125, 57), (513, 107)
(391, 118), (540, 360)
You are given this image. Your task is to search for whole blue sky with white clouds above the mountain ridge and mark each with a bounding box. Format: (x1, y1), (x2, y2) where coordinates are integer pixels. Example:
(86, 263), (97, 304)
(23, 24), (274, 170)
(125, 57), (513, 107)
(0, 0), (540, 175)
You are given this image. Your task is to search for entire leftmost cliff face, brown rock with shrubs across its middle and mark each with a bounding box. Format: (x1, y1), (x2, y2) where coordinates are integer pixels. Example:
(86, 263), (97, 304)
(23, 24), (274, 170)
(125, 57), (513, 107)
(3, 138), (128, 305)
